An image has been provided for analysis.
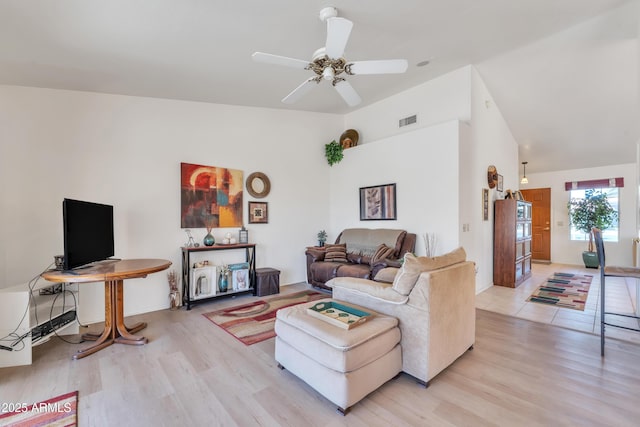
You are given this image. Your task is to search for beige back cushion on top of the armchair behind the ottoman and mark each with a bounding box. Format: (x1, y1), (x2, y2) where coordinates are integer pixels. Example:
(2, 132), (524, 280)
(393, 247), (467, 295)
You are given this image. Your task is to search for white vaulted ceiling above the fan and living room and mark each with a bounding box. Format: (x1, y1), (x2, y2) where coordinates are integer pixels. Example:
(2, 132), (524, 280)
(0, 0), (640, 173)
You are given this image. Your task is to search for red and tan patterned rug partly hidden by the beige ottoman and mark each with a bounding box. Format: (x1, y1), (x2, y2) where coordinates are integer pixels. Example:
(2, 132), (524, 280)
(203, 290), (329, 345)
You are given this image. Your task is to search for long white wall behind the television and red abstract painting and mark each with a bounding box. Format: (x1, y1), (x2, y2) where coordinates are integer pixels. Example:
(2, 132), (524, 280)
(0, 86), (343, 322)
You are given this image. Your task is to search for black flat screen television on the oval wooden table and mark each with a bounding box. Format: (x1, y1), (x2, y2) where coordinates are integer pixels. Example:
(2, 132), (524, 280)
(62, 199), (114, 270)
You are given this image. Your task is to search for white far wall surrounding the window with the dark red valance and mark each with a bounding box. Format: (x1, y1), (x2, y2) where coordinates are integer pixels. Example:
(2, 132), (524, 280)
(522, 163), (638, 266)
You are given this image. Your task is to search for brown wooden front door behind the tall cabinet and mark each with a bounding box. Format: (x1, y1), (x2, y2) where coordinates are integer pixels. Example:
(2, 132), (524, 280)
(520, 188), (551, 261)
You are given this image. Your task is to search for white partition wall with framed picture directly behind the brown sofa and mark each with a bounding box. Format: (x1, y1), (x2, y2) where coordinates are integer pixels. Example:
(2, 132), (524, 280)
(327, 121), (460, 255)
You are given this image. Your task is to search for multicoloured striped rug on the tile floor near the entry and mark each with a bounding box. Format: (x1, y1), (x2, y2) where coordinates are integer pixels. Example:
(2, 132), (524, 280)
(527, 273), (593, 311)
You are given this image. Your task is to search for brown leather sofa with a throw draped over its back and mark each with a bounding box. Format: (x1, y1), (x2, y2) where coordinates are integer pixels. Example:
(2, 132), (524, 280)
(305, 228), (416, 290)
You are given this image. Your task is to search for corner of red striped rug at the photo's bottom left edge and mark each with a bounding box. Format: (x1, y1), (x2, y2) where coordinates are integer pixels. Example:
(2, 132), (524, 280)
(0, 391), (78, 427)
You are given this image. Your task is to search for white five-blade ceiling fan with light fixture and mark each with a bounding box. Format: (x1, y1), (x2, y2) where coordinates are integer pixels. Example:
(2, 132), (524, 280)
(251, 7), (408, 107)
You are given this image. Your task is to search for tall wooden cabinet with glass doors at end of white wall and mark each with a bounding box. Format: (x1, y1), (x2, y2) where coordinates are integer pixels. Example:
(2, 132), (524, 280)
(493, 199), (531, 288)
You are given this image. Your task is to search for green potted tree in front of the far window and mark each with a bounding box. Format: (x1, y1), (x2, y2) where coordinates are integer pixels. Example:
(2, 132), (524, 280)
(567, 190), (618, 268)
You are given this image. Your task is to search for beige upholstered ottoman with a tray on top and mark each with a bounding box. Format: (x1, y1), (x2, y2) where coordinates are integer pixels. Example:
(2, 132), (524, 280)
(275, 299), (402, 414)
